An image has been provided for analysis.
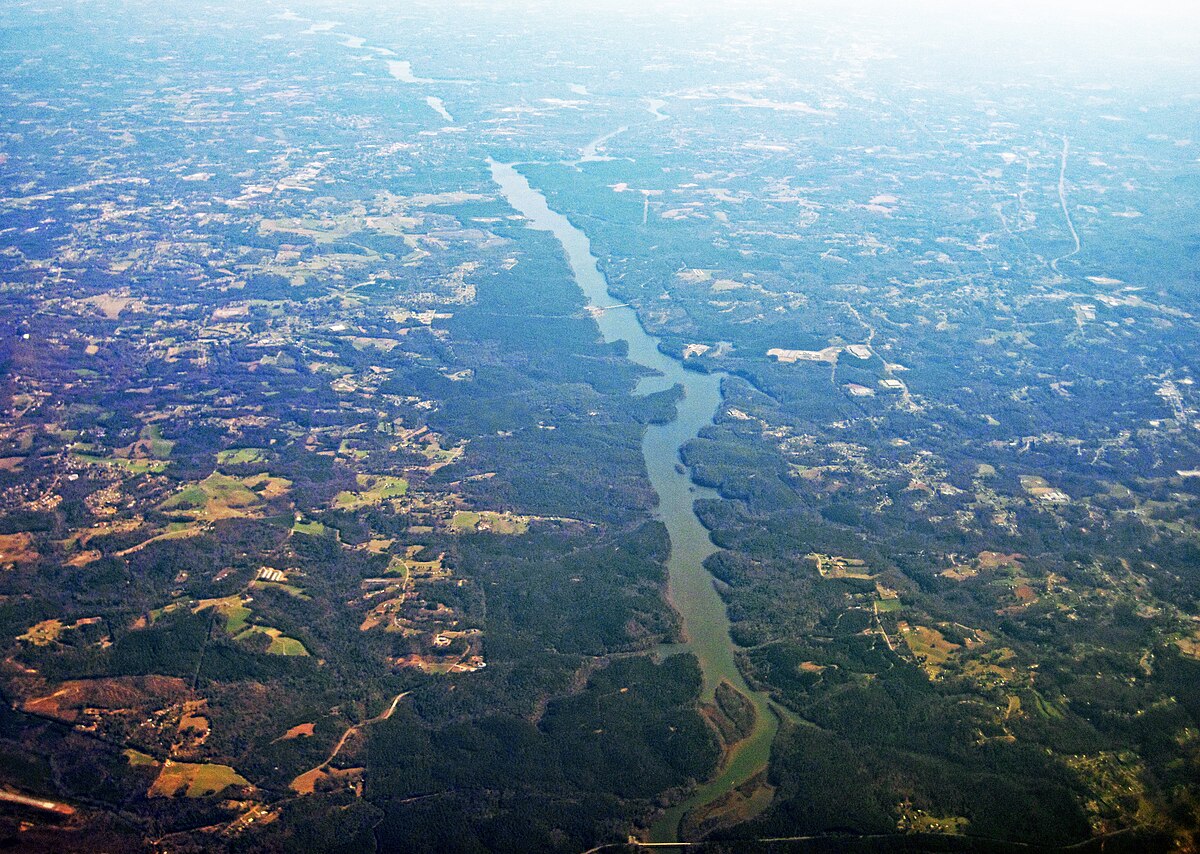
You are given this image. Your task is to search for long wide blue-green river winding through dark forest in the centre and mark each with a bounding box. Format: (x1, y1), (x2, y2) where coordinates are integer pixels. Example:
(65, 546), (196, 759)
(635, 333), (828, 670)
(488, 161), (779, 842)
